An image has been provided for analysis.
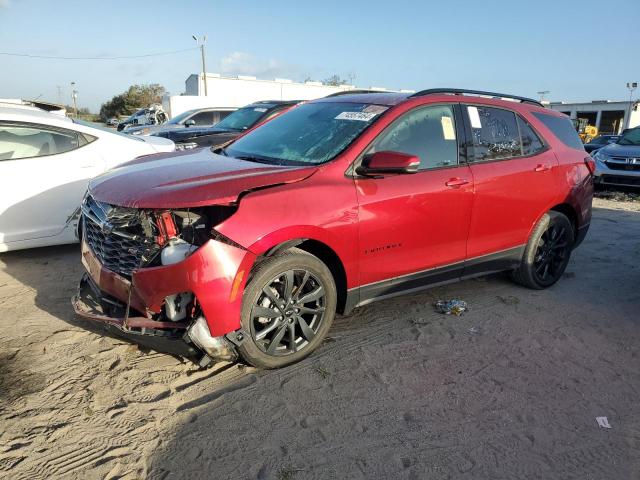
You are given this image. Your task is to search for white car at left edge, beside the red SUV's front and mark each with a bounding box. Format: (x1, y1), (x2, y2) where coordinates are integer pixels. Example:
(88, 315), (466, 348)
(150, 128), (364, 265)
(0, 102), (175, 252)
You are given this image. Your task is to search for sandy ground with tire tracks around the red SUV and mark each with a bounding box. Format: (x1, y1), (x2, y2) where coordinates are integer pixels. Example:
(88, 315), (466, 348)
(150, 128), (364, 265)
(0, 200), (640, 480)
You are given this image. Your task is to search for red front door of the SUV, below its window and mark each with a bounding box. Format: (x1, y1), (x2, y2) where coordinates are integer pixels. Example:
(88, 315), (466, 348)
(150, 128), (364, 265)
(356, 165), (473, 285)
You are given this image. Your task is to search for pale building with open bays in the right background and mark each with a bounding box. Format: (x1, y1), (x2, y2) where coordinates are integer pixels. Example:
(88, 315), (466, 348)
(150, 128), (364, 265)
(549, 100), (640, 134)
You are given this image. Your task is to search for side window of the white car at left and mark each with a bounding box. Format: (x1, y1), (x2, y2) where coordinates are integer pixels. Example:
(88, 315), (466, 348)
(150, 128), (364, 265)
(0, 125), (93, 160)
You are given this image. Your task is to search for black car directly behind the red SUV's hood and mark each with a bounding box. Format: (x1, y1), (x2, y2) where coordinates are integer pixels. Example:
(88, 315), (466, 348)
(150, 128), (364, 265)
(153, 100), (300, 150)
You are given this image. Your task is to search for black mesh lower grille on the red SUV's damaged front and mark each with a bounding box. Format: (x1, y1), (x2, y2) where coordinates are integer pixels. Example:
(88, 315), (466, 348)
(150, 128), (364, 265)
(84, 216), (145, 278)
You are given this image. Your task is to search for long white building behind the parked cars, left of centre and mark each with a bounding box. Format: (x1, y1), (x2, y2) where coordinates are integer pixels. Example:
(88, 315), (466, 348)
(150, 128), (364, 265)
(162, 73), (408, 118)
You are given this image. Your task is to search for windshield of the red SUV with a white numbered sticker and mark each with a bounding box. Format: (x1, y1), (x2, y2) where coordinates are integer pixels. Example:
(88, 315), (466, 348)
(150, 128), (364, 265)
(224, 102), (388, 165)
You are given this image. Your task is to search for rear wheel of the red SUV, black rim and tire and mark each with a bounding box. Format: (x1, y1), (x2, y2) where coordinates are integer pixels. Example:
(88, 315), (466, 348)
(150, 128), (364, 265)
(512, 210), (575, 290)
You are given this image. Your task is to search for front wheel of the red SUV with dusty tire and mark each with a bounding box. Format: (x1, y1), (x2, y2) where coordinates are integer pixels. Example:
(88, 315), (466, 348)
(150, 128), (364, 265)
(238, 248), (337, 368)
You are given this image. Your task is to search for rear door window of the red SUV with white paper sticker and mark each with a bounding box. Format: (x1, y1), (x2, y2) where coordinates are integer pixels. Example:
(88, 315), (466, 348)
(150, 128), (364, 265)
(467, 105), (522, 162)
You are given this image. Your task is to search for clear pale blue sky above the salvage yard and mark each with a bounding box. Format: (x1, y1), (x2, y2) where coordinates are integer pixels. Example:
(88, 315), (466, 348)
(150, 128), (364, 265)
(0, 0), (640, 112)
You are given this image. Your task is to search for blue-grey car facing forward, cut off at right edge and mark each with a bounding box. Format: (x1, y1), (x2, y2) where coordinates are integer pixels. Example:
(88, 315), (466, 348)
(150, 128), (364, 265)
(593, 127), (640, 187)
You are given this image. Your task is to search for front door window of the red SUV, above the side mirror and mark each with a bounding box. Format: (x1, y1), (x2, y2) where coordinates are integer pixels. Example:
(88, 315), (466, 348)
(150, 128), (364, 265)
(367, 105), (458, 170)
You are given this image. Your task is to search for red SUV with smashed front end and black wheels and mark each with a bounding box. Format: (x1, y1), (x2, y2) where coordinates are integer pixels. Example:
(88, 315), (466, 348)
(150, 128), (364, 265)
(73, 89), (595, 368)
